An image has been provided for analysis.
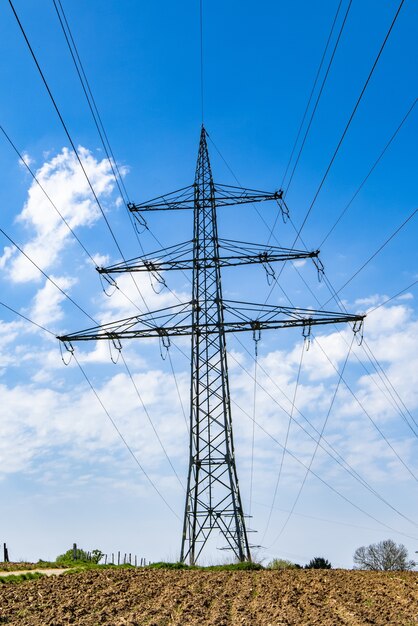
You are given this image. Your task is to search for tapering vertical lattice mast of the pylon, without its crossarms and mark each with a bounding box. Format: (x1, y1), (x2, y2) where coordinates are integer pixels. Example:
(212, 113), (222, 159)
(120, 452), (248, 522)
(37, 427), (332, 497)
(180, 128), (251, 563)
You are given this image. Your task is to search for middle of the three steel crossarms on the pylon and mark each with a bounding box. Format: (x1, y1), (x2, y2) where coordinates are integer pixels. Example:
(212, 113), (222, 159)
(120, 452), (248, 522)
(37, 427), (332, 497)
(97, 239), (319, 274)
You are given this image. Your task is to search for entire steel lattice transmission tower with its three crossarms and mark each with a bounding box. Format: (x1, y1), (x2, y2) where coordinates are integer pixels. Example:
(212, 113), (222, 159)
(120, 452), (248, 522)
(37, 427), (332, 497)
(59, 126), (363, 564)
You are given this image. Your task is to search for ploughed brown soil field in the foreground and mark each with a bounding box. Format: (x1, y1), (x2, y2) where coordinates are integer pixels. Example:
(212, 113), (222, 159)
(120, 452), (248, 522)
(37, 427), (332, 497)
(0, 569), (418, 626)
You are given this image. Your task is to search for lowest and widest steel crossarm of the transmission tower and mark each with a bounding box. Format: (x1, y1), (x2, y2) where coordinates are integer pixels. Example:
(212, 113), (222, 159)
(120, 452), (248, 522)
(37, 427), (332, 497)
(58, 300), (365, 343)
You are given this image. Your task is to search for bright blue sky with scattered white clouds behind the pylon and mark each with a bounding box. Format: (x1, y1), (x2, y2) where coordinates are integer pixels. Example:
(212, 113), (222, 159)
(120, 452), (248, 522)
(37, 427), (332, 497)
(0, 0), (418, 567)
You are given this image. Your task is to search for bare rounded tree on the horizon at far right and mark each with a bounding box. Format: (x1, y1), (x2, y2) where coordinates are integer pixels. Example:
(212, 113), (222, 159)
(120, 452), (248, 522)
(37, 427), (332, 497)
(353, 539), (416, 571)
